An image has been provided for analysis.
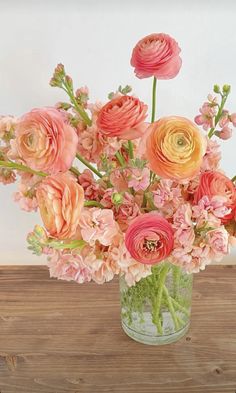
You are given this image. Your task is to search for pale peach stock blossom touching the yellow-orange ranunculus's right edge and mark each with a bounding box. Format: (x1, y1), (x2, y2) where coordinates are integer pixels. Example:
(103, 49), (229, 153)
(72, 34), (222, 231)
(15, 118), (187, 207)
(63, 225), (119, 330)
(201, 138), (221, 172)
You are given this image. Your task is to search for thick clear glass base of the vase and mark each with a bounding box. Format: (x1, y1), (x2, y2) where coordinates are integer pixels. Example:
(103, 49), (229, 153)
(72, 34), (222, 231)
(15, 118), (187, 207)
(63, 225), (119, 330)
(122, 321), (190, 345)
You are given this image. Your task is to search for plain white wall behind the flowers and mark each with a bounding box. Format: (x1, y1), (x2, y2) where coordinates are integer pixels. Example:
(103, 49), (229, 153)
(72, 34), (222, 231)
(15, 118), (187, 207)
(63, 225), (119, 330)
(0, 0), (236, 264)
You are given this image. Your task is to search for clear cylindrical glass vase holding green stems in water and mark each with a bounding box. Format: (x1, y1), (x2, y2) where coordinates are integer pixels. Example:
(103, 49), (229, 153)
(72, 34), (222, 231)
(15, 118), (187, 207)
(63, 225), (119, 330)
(120, 262), (193, 345)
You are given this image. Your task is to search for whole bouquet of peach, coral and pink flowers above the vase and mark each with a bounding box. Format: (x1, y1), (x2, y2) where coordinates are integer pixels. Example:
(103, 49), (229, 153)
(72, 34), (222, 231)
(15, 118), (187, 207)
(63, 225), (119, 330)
(0, 34), (236, 344)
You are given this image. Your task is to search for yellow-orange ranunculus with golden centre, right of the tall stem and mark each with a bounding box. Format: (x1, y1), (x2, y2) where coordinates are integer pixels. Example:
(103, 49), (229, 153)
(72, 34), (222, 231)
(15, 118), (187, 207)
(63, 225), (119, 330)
(145, 116), (206, 181)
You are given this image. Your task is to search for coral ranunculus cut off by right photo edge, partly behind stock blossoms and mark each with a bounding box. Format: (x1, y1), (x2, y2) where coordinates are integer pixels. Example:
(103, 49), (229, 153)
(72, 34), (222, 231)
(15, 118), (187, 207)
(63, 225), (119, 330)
(194, 171), (236, 221)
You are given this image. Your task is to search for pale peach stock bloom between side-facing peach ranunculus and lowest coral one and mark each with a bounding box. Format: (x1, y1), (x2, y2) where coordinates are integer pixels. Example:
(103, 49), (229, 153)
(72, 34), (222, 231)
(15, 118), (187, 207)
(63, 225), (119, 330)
(80, 207), (118, 246)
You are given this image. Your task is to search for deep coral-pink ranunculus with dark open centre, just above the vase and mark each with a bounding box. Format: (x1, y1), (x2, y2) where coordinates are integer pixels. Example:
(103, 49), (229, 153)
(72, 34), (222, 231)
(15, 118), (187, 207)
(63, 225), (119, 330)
(125, 212), (174, 265)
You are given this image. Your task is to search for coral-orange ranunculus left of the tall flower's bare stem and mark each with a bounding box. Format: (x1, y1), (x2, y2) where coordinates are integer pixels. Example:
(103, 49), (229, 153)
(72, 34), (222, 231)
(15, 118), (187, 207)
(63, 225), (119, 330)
(97, 95), (148, 139)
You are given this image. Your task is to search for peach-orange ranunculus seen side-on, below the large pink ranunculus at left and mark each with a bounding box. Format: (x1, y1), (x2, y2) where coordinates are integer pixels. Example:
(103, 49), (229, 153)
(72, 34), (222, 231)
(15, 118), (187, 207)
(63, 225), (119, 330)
(36, 173), (84, 240)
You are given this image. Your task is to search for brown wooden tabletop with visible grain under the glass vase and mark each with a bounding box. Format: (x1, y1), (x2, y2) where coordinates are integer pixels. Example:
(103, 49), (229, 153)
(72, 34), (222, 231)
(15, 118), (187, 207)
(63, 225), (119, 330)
(0, 266), (236, 393)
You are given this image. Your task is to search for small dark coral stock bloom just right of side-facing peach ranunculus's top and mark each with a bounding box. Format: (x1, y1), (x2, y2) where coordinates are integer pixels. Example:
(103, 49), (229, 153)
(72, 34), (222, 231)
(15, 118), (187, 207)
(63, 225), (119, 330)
(79, 169), (105, 201)
